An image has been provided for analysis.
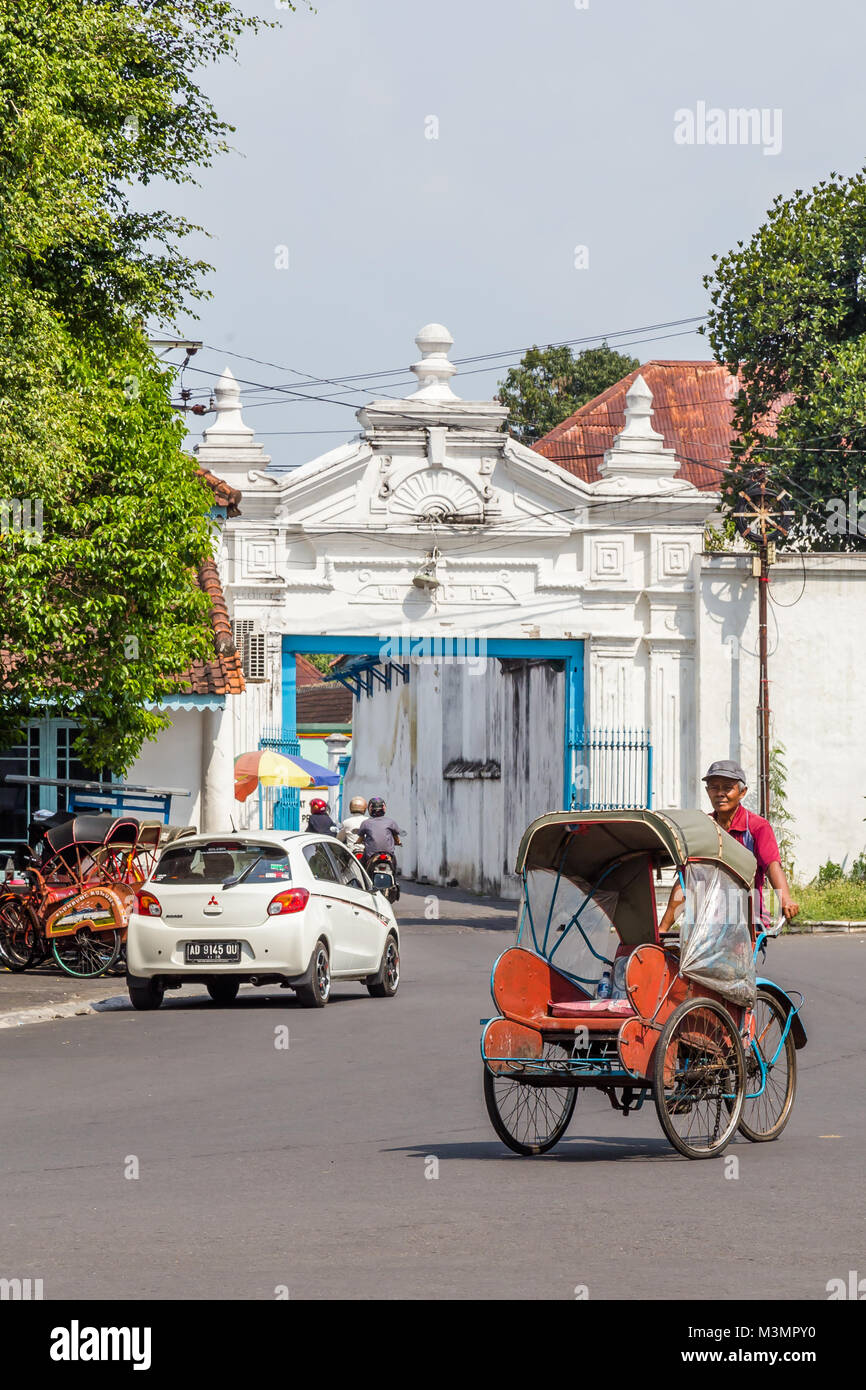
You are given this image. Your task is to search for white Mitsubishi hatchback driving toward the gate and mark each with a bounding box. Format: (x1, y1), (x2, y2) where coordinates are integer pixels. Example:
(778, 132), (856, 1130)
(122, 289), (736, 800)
(126, 830), (400, 1009)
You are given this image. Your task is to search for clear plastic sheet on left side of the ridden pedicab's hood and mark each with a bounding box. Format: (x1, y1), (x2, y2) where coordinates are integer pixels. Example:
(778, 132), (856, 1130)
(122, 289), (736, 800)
(517, 869), (619, 994)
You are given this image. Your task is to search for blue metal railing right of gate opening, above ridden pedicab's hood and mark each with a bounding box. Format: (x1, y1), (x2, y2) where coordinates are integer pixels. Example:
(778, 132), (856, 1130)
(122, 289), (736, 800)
(570, 728), (652, 810)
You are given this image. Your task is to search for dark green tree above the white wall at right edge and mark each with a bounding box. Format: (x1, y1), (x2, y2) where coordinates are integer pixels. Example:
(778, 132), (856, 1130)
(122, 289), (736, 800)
(703, 172), (866, 550)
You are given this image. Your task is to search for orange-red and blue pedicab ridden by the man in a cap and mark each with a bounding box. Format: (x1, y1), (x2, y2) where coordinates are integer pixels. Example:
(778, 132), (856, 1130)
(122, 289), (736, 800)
(481, 810), (806, 1158)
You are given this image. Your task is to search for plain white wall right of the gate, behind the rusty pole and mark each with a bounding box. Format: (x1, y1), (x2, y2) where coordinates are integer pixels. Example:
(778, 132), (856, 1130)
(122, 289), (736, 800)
(694, 555), (866, 881)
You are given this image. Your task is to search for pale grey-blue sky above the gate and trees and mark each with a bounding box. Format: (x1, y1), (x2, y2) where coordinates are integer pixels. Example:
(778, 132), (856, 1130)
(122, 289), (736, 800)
(150, 0), (866, 467)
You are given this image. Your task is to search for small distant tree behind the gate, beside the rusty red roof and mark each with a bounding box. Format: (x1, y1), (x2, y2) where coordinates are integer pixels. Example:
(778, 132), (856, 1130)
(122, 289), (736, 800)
(499, 343), (641, 445)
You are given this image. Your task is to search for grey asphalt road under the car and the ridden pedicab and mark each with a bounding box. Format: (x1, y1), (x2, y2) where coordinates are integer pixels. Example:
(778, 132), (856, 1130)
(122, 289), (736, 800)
(0, 894), (866, 1300)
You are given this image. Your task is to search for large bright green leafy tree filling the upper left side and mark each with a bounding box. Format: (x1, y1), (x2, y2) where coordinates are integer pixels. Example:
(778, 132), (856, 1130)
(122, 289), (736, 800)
(0, 0), (297, 771)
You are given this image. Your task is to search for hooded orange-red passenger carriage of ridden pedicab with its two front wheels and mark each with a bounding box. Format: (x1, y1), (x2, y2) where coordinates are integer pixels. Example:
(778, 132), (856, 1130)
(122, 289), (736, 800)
(481, 810), (781, 1158)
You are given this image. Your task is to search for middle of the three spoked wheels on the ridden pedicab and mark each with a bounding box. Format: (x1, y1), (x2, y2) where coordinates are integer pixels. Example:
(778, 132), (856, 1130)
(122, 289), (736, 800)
(652, 998), (745, 1158)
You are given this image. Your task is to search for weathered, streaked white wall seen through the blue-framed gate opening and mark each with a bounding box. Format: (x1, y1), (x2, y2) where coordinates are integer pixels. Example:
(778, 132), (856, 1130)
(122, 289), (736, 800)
(345, 659), (564, 897)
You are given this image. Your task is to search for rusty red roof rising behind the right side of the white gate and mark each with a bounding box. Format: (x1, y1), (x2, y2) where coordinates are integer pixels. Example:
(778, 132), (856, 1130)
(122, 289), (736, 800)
(534, 361), (737, 489)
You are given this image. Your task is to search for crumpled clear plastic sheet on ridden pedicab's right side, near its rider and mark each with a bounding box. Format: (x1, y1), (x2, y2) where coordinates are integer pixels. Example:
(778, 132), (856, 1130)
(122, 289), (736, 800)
(680, 863), (755, 1008)
